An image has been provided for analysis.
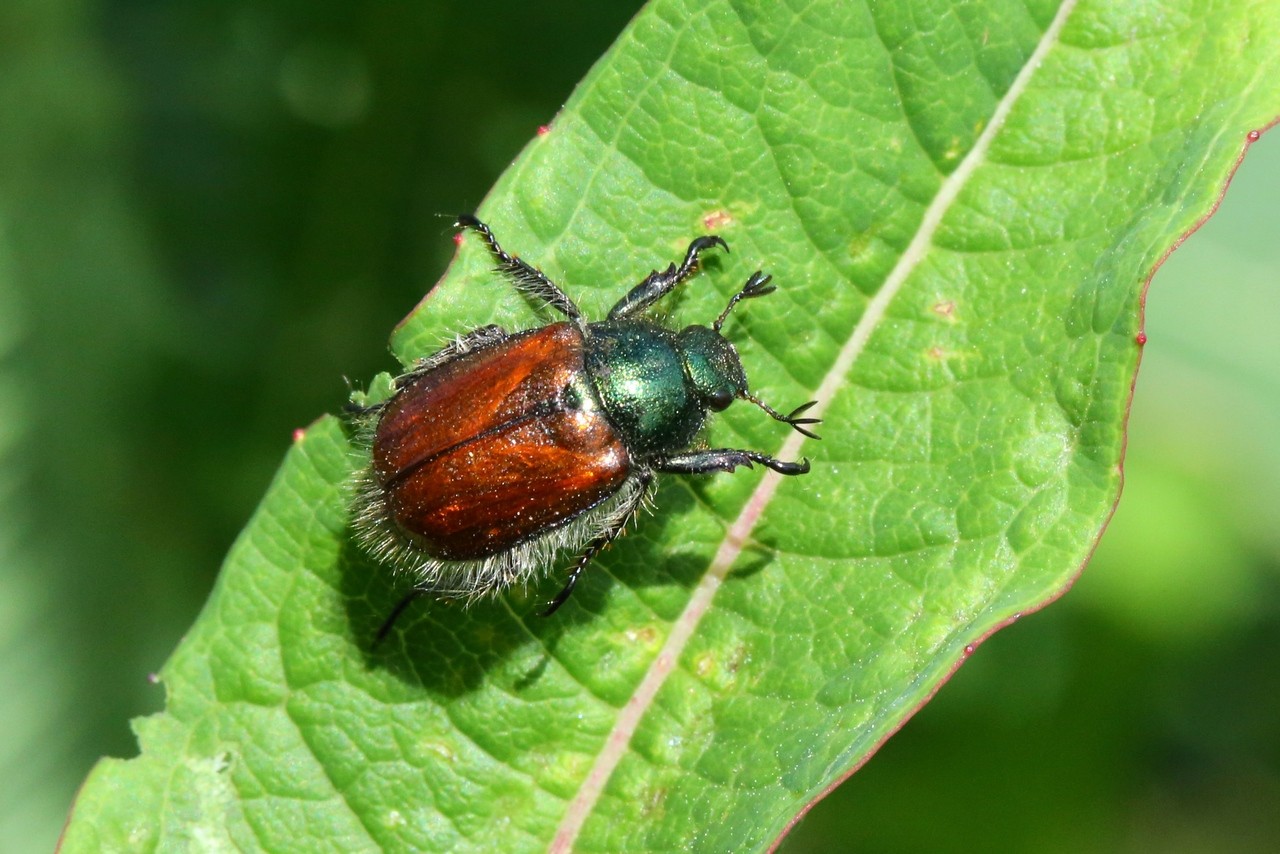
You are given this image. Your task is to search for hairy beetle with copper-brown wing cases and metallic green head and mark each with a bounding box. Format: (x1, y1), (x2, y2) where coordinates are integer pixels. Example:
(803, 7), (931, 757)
(353, 214), (818, 627)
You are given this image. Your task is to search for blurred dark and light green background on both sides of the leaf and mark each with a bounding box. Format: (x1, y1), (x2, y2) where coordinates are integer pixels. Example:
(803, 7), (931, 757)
(0, 0), (1280, 853)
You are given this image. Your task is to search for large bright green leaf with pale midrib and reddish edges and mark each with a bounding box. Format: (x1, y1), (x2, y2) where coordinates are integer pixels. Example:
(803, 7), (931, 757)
(65, 0), (1280, 851)
